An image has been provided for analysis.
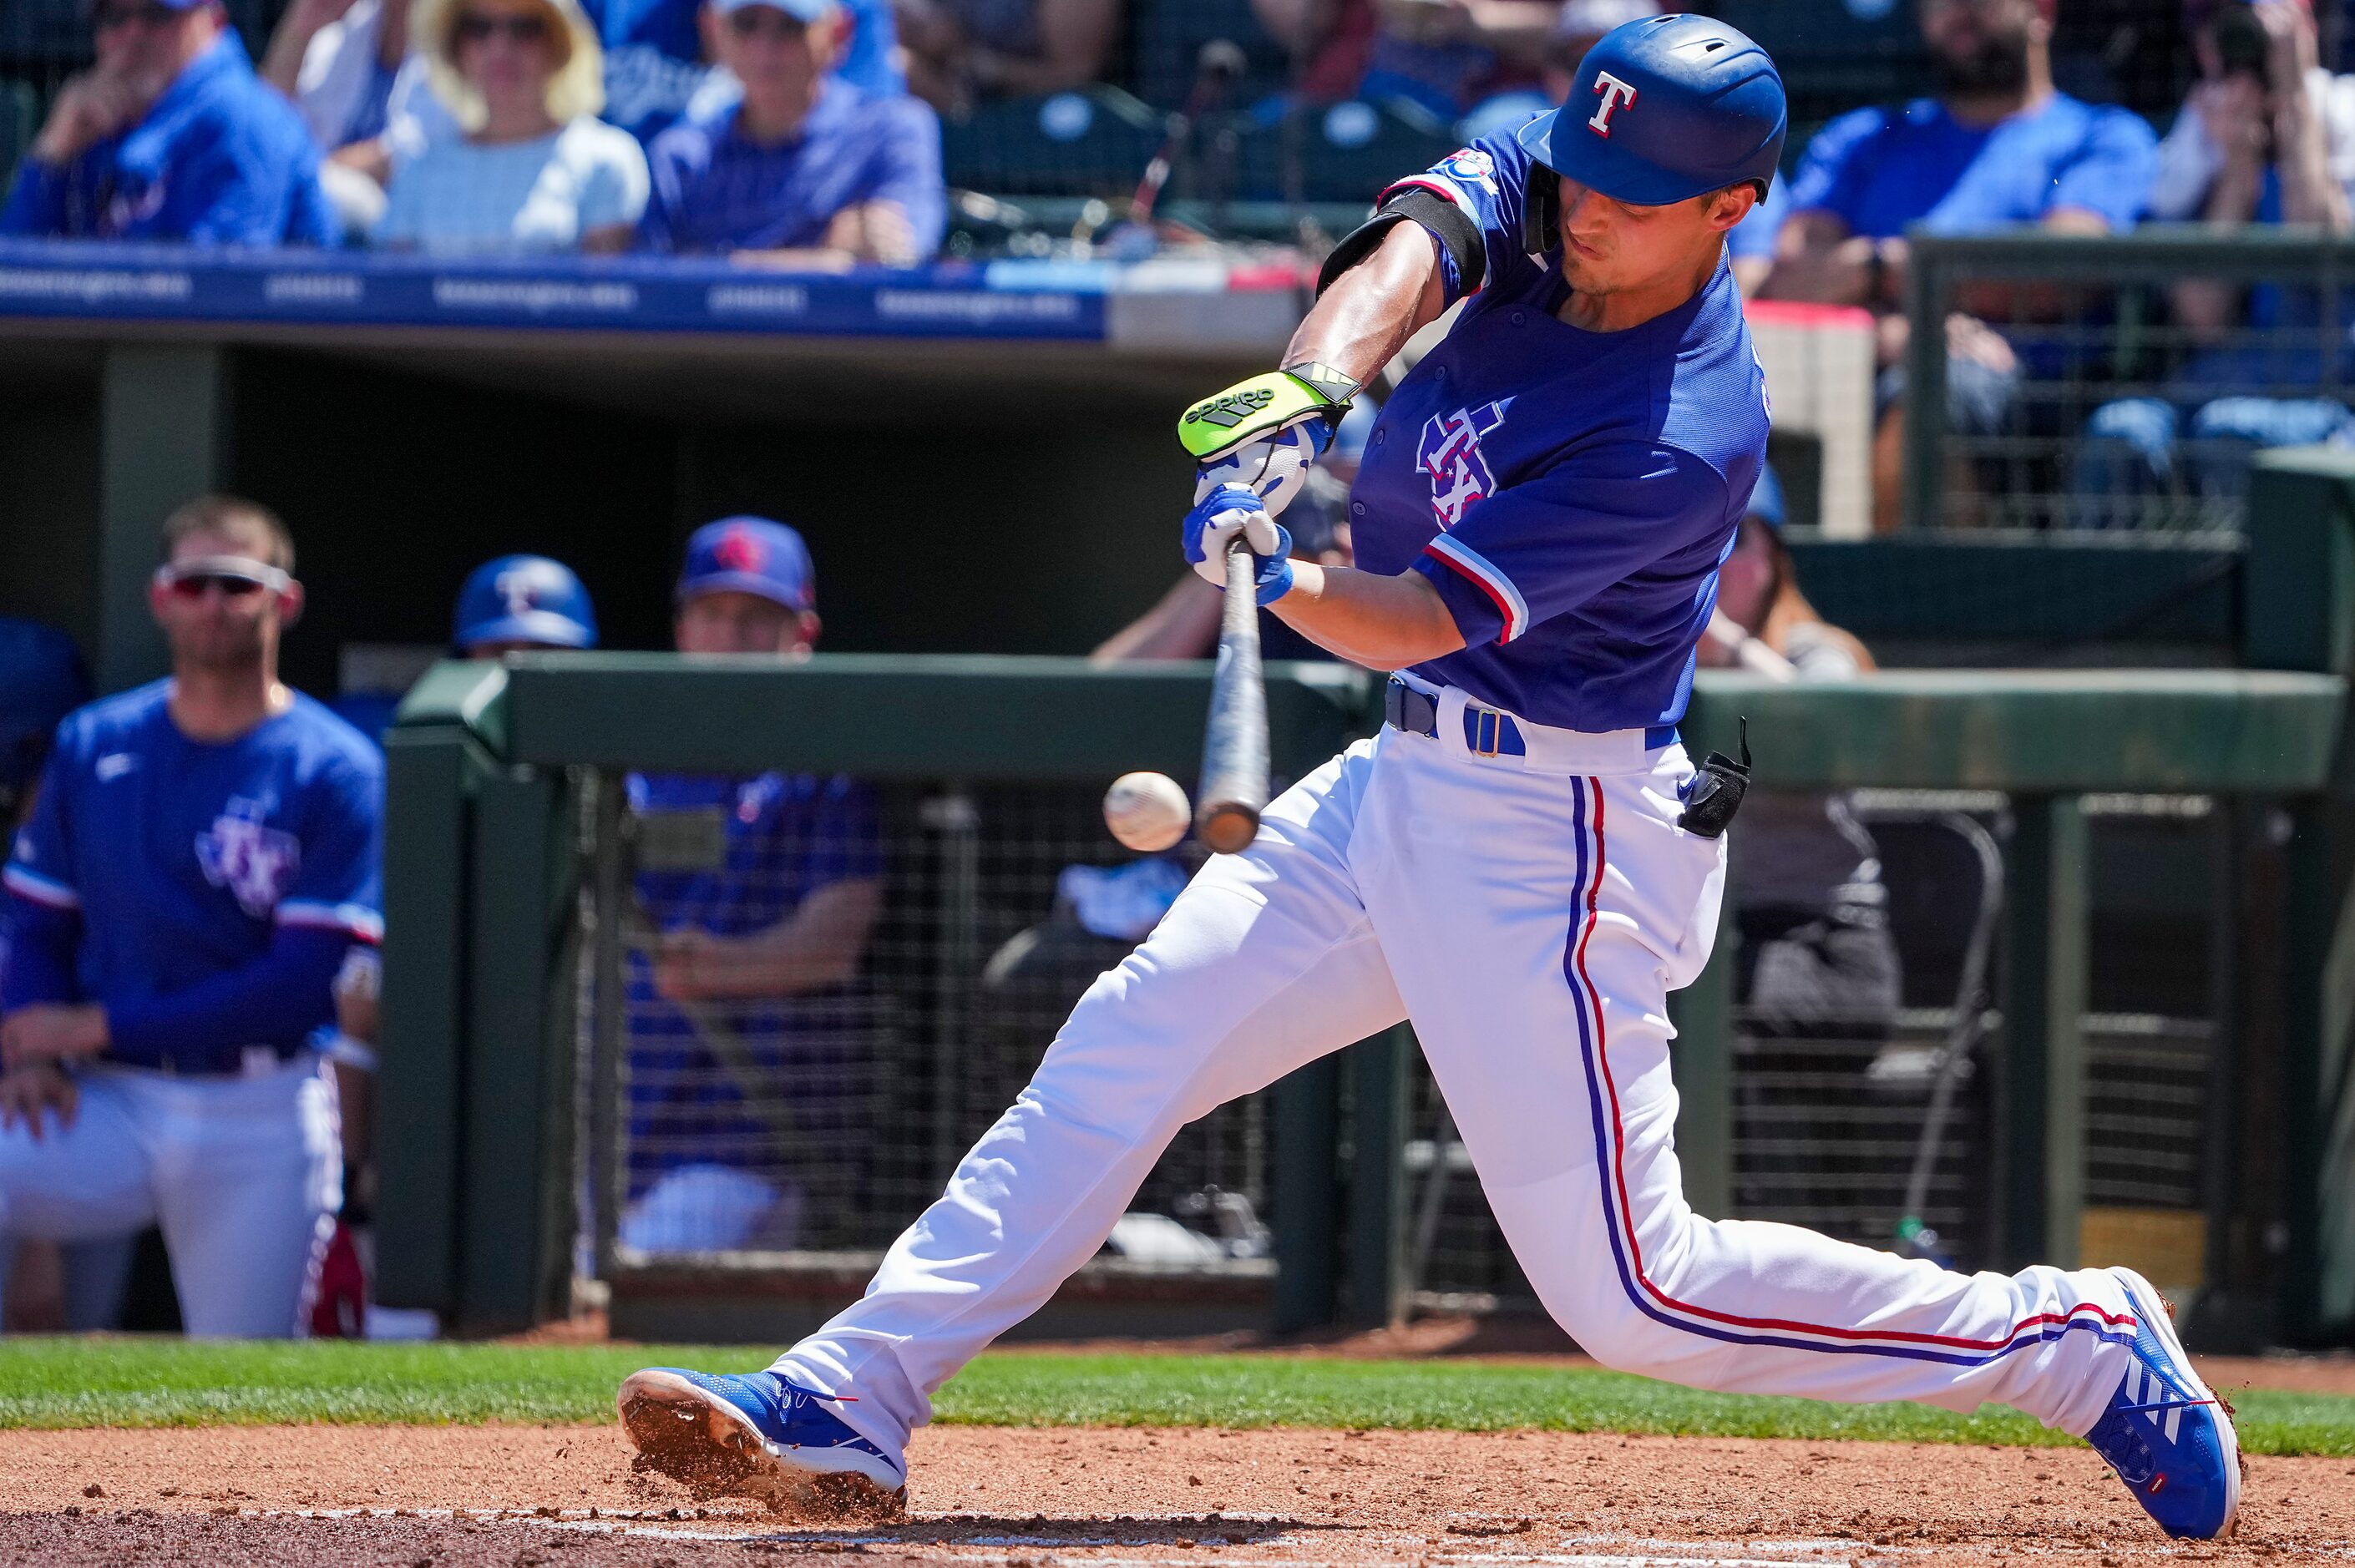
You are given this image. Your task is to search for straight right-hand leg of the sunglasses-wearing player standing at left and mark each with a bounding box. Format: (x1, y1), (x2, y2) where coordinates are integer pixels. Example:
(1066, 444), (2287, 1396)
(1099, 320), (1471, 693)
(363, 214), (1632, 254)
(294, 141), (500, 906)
(141, 1055), (344, 1339)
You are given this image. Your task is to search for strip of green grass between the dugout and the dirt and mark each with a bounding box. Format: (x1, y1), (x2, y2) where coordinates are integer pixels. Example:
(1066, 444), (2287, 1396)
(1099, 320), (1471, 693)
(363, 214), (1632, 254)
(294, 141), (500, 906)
(0, 1339), (2355, 1455)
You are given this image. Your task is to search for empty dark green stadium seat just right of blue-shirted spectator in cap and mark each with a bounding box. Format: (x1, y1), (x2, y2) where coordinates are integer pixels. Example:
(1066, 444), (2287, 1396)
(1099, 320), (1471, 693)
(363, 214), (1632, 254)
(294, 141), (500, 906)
(939, 85), (1166, 198)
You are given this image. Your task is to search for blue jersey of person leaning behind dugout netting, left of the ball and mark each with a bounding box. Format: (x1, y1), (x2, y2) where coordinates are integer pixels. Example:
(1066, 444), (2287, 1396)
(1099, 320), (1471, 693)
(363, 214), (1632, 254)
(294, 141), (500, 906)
(629, 772), (884, 1196)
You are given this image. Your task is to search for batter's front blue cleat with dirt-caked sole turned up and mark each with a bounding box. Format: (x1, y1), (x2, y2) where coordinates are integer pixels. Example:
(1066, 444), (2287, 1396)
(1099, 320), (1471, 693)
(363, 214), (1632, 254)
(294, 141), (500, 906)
(615, 1365), (907, 1519)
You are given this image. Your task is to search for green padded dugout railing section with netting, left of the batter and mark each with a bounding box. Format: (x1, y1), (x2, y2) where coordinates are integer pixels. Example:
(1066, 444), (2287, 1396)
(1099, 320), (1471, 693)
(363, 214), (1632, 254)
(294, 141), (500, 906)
(379, 655), (1366, 1338)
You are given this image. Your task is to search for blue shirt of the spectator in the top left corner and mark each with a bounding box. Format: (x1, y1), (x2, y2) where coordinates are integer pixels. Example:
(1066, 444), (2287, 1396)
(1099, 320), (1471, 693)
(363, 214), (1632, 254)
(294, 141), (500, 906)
(0, 33), (342, 247)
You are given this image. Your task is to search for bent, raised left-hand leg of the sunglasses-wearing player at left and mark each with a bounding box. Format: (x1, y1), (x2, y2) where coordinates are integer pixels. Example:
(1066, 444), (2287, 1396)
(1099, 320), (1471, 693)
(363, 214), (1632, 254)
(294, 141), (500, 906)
(0, 1069), (155, 1302)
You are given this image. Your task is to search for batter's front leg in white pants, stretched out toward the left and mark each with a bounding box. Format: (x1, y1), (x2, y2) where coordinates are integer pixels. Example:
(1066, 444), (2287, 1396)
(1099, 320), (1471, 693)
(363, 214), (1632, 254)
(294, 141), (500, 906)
(621, 749), (1404, 1485)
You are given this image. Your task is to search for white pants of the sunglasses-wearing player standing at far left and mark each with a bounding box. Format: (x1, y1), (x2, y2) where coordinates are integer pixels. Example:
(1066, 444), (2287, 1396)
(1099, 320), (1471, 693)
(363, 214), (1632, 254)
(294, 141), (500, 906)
(0, 1052), (344, 1339)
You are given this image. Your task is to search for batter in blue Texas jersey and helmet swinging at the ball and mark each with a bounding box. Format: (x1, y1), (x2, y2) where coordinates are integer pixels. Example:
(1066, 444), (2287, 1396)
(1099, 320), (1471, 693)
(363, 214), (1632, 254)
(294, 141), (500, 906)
(620, 17), (2240, 1537)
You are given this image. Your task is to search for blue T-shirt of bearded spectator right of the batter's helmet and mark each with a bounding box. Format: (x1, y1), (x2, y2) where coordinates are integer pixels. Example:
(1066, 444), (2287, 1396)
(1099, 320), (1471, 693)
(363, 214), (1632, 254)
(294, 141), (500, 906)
(1790, 92), (2157, 240)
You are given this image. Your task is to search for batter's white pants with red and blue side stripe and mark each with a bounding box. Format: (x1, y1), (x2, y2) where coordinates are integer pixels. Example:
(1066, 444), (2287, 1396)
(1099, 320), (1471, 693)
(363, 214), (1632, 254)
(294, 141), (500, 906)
(777, 690), (2134, 1453)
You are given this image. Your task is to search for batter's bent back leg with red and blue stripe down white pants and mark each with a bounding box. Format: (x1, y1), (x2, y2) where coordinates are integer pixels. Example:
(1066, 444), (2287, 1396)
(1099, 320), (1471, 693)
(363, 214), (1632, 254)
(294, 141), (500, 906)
(1359, 726), (2134, 1434)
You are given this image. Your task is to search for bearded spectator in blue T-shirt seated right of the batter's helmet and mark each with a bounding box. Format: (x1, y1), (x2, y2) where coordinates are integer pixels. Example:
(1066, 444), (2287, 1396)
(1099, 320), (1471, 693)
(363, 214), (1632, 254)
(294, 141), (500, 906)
(1760, 0), (2152, 528)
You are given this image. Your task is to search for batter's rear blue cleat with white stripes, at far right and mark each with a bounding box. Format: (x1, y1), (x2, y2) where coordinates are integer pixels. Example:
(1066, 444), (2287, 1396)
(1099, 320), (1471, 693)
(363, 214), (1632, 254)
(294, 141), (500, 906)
(2084, 1269), (2240, 1540)
